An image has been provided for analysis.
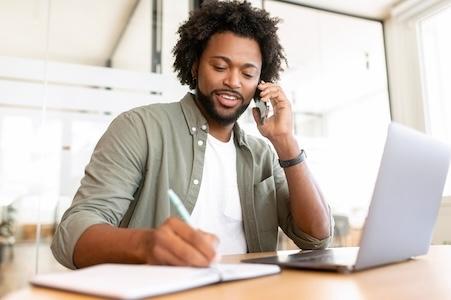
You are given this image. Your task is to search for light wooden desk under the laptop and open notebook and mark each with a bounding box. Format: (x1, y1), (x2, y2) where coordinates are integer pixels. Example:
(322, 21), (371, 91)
(5, 246), (451, 300)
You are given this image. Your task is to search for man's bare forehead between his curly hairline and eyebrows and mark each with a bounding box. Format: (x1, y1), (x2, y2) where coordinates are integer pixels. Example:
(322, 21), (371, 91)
(201, 32), (262, 67)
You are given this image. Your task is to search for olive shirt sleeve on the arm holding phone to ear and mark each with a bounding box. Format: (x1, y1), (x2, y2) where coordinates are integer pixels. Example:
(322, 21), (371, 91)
(274, 157), (334, 250)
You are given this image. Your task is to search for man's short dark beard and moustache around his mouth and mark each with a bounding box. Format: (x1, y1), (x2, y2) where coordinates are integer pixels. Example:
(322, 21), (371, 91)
(196, 86), (250, 126)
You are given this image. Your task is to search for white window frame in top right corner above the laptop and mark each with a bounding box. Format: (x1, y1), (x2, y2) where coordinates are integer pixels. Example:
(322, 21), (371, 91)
(384, 0), (451, 205)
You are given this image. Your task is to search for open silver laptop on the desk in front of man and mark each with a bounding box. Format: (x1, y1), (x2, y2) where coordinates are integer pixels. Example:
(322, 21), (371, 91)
(243, 123), (451, 272)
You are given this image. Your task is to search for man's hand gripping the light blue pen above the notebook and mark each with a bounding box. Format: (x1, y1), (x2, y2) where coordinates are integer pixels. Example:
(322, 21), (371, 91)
(144, 217), (218, 267)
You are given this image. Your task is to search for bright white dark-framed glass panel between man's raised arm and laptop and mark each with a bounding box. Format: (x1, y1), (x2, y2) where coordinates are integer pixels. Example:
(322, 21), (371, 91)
(264, 1), (390, 226)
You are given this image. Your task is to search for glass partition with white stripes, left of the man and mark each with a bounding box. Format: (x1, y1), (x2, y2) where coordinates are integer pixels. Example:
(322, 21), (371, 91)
(0, 0), (190, 295)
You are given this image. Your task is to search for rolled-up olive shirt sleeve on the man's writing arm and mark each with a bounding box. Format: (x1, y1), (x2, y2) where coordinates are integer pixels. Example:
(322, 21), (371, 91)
(51, 111), (147, 269)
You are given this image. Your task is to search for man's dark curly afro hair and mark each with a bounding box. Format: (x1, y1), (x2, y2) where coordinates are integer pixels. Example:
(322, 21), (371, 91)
(172, 0), (287, 89)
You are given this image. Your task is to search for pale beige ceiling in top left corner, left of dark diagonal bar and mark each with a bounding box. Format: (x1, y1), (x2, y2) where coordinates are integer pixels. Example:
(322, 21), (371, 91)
(0, 0), (137, 65)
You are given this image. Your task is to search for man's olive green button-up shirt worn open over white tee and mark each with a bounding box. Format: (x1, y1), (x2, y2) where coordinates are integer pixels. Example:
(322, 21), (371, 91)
(52, 93), (332, 269)
